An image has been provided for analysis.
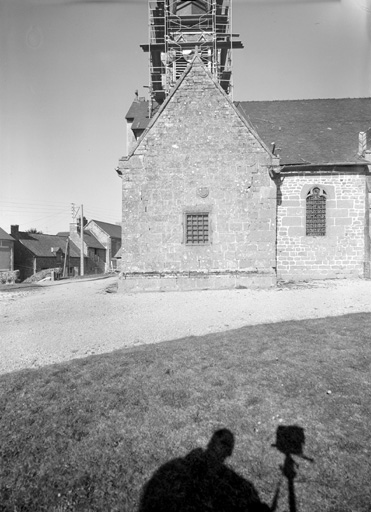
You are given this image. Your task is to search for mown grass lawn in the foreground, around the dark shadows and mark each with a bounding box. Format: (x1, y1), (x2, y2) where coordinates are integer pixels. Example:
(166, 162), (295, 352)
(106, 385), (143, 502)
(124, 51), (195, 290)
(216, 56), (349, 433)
(0, 314), (371, 512)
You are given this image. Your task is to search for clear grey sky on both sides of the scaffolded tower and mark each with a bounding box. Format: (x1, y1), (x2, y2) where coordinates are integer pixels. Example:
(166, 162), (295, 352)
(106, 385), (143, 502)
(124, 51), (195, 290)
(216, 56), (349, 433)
(0, 0), (371, 234)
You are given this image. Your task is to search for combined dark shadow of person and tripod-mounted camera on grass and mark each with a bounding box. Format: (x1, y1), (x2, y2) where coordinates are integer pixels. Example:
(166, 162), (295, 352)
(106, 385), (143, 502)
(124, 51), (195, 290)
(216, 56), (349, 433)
(138, 425), (314, 512)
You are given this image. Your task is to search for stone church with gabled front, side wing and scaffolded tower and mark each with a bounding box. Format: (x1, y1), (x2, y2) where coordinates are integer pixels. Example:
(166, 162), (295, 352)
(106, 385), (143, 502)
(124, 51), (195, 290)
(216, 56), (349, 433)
(117, 0), (371, 291)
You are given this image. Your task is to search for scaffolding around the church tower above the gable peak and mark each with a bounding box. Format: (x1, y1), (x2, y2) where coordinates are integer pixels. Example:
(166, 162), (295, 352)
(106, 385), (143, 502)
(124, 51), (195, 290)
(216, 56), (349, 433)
(141, 0), (243, 110)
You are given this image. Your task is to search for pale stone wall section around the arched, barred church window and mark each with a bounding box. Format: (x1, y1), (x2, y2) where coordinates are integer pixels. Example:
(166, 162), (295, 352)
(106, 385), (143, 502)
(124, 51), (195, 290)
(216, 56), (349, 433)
(277, 173), (369, 280)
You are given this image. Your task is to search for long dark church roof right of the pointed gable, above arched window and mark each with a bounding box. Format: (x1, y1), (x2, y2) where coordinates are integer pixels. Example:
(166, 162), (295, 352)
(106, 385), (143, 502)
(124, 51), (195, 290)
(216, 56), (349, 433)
(236, 98), (371, 164)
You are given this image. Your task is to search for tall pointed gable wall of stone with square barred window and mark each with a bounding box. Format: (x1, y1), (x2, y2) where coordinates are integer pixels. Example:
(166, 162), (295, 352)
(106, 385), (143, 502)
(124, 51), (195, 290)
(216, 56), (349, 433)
(120, 58), (276, 290)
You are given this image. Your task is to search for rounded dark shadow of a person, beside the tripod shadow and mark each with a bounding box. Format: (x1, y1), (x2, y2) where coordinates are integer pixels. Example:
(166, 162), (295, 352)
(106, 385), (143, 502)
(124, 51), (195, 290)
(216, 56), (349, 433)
(139, 429), (270, 512)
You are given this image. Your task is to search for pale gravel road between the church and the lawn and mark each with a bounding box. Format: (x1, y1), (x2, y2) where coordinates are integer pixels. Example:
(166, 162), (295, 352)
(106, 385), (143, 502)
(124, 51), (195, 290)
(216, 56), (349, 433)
(0, 277), (371, 373)
